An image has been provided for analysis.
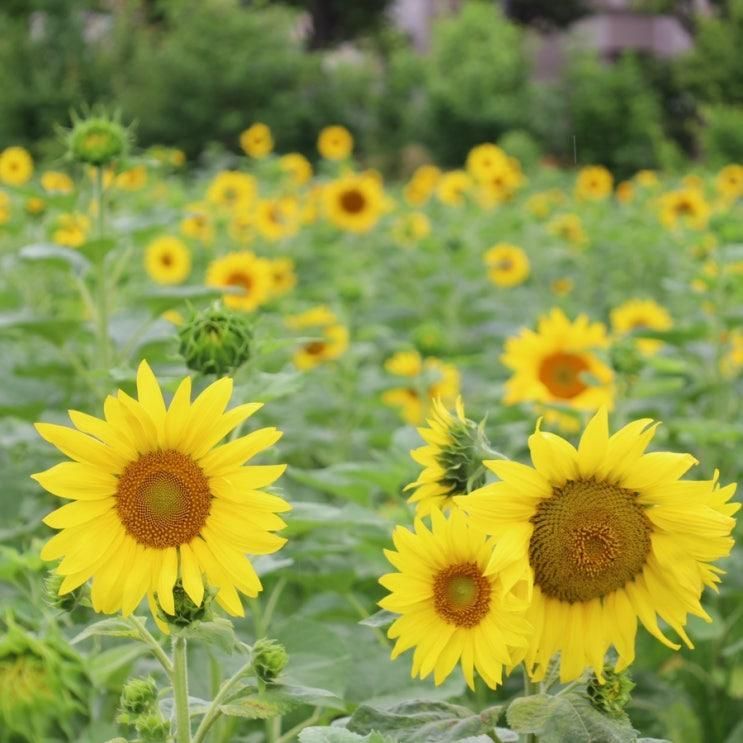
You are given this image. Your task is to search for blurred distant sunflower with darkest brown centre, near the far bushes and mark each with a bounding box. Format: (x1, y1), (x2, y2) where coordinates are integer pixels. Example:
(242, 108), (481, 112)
(322, 173), (385, 232)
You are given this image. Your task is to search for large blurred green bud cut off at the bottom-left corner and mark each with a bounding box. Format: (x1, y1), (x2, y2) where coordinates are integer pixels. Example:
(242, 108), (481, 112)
(0, 619), (90, 741)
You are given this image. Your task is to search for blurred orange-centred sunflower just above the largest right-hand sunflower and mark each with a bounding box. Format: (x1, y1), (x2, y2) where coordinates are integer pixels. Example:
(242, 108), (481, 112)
(501, 308), (614, 410)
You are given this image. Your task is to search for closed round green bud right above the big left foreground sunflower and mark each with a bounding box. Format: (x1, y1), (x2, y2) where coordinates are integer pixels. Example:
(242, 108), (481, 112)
(178, 306), (253, 376)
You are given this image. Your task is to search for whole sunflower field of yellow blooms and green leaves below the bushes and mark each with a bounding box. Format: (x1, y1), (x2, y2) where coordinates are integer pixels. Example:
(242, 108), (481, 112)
(0, 110), (743, 743)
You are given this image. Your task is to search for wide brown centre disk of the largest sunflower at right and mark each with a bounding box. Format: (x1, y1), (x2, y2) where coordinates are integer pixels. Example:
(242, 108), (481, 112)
(529, 480), (651, 604)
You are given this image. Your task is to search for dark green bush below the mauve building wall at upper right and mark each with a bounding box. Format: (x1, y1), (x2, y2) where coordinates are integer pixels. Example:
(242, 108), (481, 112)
(533, 53), (678, 177)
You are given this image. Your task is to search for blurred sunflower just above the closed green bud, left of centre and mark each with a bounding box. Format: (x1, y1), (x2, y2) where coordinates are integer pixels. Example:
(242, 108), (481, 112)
(206, 250), (272, 312)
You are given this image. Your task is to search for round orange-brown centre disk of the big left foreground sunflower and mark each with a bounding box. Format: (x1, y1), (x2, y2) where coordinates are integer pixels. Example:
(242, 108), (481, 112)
(116, 451), (212, 549)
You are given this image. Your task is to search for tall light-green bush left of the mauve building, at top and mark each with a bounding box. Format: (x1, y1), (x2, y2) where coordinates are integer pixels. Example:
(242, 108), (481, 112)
(419, 1), (529, 165)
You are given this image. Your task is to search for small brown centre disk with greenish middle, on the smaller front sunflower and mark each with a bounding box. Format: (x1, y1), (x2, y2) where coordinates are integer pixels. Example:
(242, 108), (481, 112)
(433, 562), (491, 627)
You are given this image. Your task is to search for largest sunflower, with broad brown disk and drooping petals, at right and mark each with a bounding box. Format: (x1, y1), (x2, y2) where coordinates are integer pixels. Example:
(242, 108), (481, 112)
(456, 408), (740, 682)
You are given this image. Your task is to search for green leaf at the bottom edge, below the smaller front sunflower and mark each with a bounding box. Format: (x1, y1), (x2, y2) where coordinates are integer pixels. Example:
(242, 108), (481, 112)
(348, 700), (503, 743)
